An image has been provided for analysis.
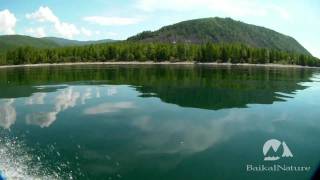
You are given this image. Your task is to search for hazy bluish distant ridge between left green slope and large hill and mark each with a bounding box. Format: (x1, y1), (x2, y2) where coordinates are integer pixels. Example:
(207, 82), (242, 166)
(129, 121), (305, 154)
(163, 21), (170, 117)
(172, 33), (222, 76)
(42, 37), (115, 46)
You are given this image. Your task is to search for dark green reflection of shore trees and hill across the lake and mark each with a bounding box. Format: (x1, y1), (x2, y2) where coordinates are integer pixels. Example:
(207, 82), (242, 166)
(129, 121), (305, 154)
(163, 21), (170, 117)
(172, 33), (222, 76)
(0, 65), (312, 109)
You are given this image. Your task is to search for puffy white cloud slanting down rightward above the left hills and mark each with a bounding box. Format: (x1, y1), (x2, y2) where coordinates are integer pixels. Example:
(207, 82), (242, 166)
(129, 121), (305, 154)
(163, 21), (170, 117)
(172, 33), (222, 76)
(26, 6), (81, 39)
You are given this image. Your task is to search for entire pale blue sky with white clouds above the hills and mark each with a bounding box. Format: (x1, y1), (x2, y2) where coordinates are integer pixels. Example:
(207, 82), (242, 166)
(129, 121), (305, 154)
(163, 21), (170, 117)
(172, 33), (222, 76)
(0, 0), (320, 57)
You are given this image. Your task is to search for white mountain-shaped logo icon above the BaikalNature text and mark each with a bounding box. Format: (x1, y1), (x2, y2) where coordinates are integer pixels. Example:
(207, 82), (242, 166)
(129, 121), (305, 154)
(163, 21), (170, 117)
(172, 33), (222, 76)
(262, 139), (293, 161)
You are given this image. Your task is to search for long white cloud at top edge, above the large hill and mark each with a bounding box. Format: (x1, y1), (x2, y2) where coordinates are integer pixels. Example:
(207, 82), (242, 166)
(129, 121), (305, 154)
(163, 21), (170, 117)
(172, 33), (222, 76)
(136, 0), (289, 19)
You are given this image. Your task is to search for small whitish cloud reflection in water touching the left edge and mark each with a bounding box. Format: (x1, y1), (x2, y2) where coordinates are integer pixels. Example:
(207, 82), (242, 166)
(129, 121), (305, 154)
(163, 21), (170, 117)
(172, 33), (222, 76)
(0, 99), (17, 129)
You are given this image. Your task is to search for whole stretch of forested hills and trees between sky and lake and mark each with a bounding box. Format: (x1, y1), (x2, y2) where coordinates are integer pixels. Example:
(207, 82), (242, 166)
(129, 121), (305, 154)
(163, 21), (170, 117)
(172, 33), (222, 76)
(0, 18), (320, 67)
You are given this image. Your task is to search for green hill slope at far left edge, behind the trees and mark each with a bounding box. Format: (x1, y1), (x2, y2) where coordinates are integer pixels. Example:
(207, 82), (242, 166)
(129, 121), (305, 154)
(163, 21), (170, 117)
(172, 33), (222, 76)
(0, 35), (59, 52)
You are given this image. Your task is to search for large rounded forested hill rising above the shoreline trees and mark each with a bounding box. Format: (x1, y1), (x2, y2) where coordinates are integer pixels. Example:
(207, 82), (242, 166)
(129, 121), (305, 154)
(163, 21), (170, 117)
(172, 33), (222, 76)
(128, 17), (310, 55)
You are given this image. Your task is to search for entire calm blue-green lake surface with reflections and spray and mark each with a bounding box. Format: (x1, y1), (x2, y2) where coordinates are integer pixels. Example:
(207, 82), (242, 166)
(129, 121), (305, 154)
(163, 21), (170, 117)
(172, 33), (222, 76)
(0, 65), (320, 180)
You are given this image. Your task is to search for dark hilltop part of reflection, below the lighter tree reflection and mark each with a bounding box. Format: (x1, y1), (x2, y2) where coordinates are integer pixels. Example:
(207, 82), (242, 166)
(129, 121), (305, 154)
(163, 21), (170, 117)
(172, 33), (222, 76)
(141, 87), (281, 110)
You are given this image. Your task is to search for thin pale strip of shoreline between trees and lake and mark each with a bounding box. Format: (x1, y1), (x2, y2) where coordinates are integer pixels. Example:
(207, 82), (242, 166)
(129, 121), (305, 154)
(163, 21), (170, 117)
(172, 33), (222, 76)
(0, 61), (320, 69)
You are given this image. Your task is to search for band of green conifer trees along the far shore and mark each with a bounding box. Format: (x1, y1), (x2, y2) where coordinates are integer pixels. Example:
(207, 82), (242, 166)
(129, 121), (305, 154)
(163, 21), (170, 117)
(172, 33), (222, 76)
(0, 42), (320, 66)
